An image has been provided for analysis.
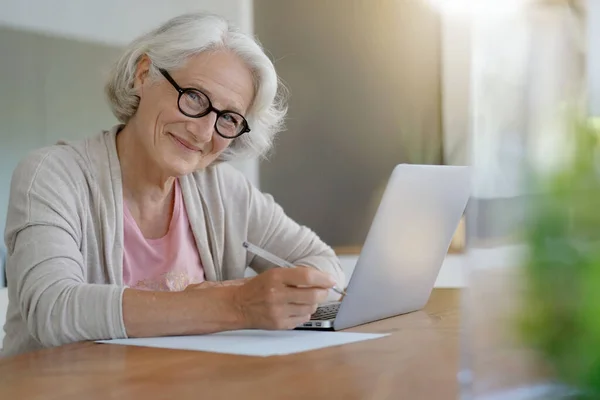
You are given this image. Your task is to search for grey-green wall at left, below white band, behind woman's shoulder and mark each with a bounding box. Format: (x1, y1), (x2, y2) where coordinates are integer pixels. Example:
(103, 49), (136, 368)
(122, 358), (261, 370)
(0, 27), (119, 241)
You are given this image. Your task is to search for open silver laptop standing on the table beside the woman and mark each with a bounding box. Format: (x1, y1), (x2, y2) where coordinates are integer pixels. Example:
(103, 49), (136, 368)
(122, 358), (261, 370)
(298, 164), (470, 330)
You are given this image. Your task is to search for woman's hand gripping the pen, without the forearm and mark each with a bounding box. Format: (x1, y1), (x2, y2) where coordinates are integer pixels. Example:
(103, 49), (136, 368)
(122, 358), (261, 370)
(233, 267), (335, 329)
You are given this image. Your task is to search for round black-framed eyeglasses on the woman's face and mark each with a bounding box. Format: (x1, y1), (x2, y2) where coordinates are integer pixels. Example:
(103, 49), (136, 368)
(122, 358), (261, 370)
(159, 68), (250, 139)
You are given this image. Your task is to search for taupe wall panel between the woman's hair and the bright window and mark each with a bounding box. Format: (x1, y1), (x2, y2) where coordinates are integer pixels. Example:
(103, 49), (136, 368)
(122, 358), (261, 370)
(254, 0), (444, 247)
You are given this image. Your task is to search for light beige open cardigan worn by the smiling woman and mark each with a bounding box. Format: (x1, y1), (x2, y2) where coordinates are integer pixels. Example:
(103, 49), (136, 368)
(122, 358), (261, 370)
(2, 126), (344, 355)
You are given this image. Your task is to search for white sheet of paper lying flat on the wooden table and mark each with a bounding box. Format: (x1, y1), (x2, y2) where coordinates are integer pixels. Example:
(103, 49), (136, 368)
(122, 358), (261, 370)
(97, 330), (387, 357)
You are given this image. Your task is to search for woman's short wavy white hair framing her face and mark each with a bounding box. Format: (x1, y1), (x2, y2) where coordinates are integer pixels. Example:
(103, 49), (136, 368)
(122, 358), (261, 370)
(105, 13), (287, 161)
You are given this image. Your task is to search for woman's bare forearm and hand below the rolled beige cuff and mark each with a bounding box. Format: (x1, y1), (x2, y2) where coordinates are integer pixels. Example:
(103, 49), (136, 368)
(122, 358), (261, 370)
(123, 267), (334, 337)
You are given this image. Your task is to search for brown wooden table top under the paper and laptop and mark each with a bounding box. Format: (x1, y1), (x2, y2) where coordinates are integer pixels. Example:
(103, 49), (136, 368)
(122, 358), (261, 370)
(0, 289), (460, 400)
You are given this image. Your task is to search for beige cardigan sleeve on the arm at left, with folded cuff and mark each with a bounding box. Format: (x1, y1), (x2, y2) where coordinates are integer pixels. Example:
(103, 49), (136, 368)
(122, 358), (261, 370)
(5, 148), (126, 347)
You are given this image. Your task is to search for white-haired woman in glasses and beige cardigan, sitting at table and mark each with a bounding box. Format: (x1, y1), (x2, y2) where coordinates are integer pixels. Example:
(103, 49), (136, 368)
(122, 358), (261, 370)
(3, 14), (344, 355)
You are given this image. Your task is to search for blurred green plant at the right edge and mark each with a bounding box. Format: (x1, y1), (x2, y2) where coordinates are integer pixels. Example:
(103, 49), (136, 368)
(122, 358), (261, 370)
(519, 115), (600, 400)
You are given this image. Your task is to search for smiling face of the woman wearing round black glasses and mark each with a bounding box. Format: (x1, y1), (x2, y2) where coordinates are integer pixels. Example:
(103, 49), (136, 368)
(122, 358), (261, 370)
(130, 50), (254, 176)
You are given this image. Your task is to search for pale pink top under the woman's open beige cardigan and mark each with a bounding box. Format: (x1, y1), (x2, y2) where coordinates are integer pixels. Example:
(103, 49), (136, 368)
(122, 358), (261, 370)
(123, 180), (204, 291)
